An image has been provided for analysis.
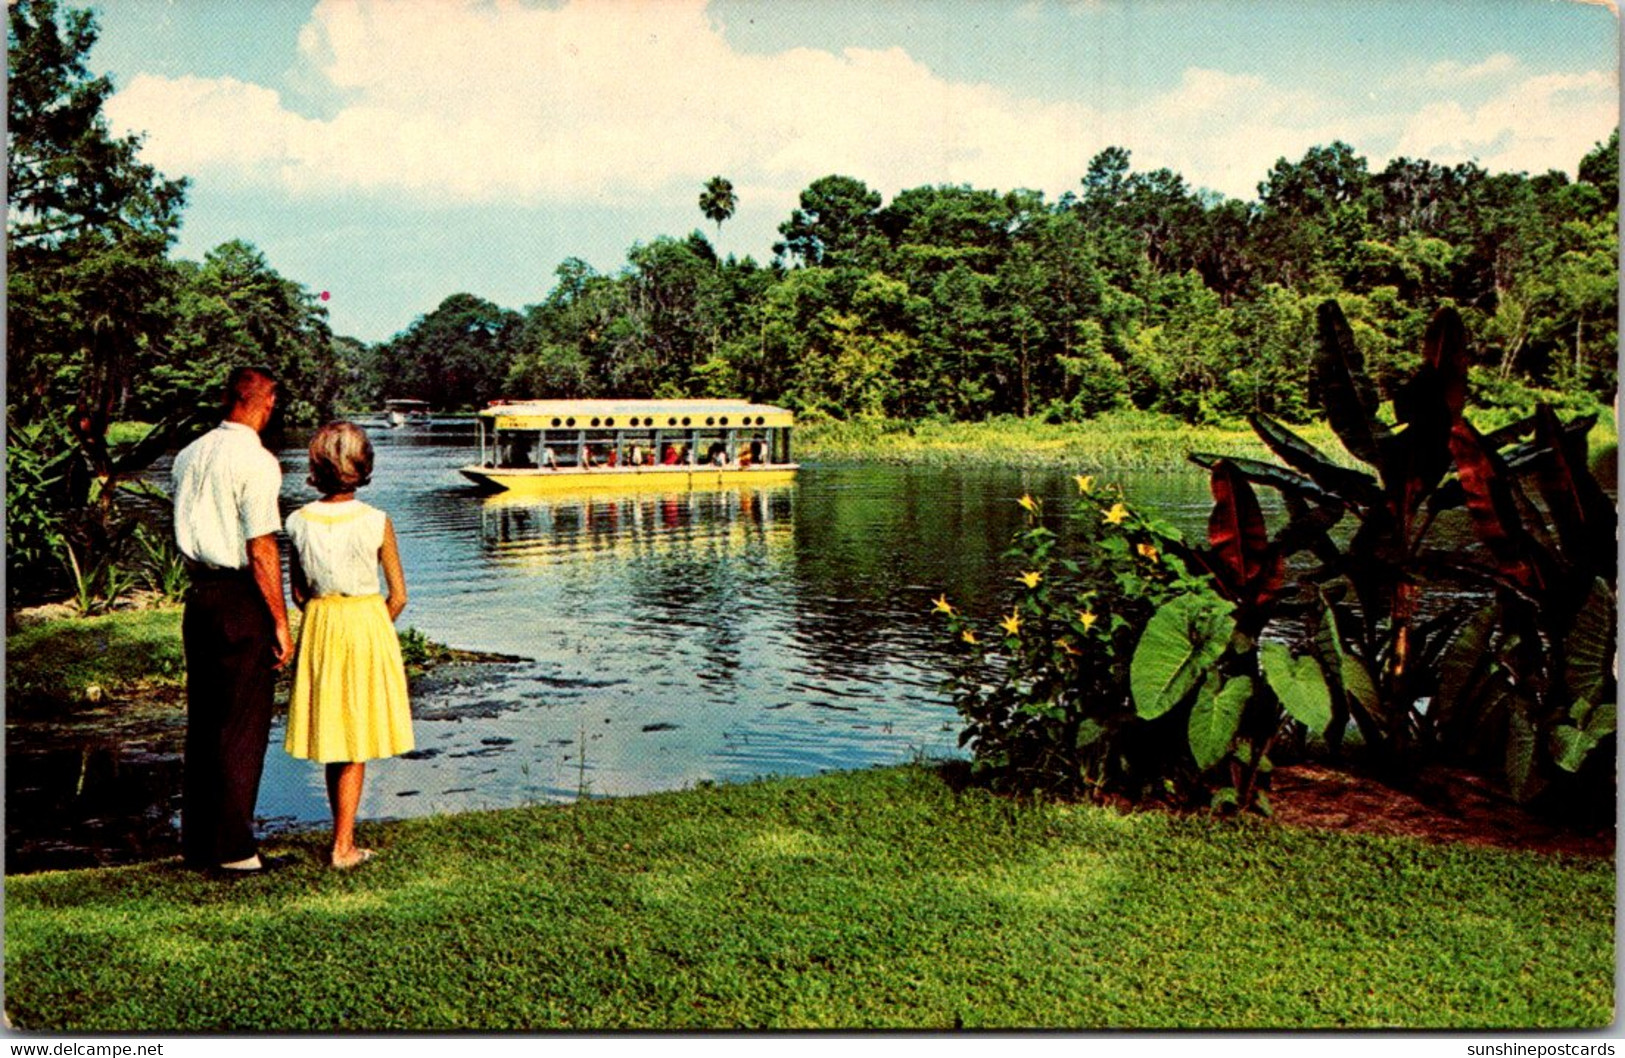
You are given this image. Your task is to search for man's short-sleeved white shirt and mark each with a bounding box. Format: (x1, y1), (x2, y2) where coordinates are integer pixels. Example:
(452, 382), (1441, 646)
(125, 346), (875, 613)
(171, 423), (283, 569)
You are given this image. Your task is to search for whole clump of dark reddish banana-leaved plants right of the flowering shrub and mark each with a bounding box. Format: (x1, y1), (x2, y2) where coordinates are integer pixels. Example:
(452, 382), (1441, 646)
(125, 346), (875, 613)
(1193, 301), (1617, 812)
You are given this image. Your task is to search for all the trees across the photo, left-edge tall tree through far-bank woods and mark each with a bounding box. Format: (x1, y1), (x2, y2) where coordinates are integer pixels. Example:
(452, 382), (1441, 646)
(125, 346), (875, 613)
(7, 0), (1619, 601)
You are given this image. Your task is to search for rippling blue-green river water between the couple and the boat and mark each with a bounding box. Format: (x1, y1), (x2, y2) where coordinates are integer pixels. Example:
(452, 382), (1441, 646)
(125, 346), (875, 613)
(7, 423), (1207, 871)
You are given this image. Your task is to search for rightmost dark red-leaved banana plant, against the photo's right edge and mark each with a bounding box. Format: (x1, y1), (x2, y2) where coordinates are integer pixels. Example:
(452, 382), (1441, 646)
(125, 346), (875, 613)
(1433, 406), (1619, 800)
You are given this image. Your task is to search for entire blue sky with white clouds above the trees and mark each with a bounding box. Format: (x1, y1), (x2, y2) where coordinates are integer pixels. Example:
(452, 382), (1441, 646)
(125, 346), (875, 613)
(92, 0), (1620, 341)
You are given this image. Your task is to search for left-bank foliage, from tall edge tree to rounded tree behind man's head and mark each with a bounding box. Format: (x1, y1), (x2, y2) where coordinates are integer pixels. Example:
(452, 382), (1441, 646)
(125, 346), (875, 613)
(7, 0), (341, 605)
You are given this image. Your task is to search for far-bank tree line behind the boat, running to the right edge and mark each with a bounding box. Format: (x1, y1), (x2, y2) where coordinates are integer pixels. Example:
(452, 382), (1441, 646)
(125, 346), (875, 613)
(362, 132), (1619, 423)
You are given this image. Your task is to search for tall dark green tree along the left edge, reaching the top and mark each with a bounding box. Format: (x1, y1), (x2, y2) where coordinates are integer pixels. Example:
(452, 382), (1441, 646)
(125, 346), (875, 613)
(7, 0), (185, 600)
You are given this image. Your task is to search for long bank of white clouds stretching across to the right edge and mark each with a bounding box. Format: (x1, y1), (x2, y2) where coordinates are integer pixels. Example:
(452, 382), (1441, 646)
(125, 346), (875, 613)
(107, 0), (1615, 205)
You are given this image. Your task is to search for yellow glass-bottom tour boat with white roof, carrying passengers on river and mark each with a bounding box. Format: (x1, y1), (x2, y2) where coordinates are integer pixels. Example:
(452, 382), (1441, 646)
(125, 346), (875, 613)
(460, 400), (800, 492)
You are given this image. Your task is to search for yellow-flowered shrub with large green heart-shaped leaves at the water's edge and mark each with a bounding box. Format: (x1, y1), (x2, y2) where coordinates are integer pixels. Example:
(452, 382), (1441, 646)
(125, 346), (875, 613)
(936, 476), (1331, 809)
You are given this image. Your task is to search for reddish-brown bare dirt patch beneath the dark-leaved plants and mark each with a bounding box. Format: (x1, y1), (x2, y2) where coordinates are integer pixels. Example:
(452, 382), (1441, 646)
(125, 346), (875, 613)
(1269, 764), (1614, 858)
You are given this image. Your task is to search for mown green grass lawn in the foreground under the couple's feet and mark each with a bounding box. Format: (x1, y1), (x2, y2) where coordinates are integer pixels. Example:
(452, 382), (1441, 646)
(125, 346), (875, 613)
(5, 767), (1614, 1032)
